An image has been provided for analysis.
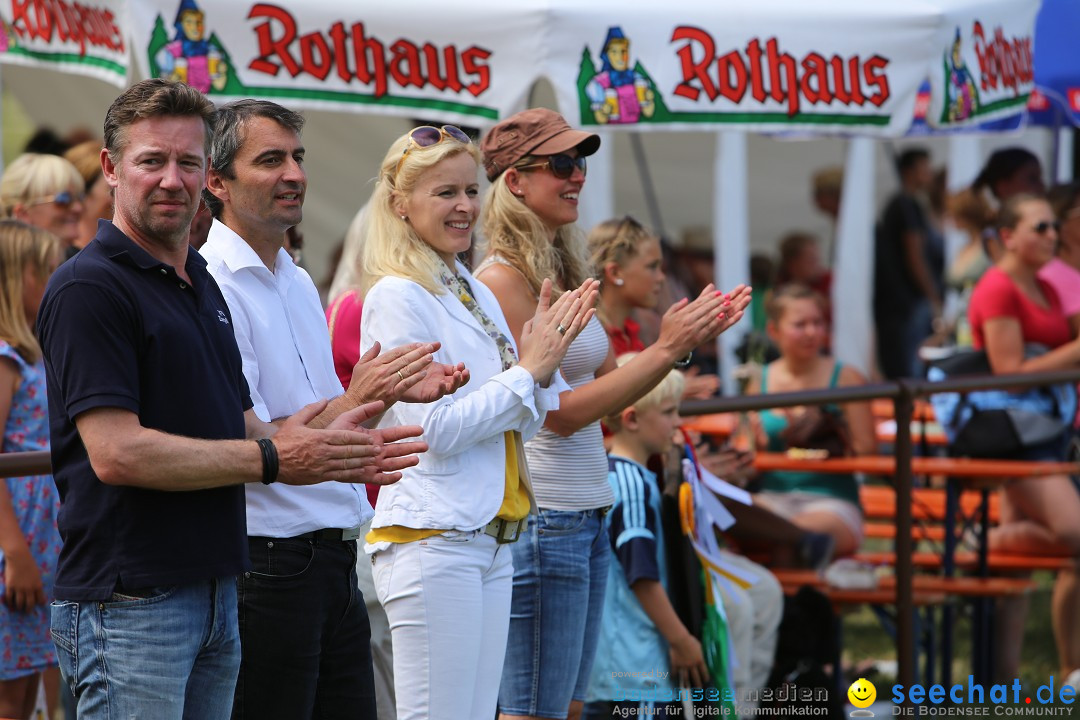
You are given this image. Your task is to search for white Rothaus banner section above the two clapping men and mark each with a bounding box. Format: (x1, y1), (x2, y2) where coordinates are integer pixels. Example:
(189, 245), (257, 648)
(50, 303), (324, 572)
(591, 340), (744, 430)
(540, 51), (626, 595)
(132, 0), (542, 125)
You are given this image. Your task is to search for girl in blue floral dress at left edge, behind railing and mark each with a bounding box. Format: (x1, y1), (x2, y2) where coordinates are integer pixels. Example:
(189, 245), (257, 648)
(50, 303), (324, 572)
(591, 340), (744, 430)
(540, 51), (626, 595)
(0, 220), (62, 719)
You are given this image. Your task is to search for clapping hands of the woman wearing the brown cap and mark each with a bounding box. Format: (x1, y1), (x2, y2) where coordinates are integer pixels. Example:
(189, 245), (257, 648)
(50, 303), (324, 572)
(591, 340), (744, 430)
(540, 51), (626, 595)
(657, 284), (751, 362)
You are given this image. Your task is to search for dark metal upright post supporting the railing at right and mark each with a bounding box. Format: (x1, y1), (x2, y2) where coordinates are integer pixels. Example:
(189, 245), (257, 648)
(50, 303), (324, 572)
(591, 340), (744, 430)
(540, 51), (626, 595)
(893, 380), (915, 704)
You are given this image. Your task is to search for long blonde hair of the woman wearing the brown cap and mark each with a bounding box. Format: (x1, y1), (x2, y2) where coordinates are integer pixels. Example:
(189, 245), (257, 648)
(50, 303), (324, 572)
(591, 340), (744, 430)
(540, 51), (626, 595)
(482, 166), (591, 297)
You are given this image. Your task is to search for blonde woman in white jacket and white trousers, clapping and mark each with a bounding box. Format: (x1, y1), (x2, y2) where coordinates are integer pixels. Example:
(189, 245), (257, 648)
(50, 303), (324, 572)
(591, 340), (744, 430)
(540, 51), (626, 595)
(361, 125), (596, 720)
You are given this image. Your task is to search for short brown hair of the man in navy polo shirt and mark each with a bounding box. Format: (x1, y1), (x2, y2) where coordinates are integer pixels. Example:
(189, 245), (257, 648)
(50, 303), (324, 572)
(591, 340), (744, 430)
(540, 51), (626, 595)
(105, 78), (215, 163)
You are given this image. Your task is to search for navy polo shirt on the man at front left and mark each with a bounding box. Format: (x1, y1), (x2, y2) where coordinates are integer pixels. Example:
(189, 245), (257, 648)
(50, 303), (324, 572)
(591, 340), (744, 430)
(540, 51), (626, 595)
(38, 220), (252, 601)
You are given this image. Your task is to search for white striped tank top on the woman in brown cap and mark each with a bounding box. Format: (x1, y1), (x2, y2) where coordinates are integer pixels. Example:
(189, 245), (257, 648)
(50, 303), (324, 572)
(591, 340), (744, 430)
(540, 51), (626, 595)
(525, 317), (615, 511)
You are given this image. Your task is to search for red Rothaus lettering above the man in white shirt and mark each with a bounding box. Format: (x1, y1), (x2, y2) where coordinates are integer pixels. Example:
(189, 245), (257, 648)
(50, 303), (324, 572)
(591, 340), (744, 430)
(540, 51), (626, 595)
(247, 3), (491, 97)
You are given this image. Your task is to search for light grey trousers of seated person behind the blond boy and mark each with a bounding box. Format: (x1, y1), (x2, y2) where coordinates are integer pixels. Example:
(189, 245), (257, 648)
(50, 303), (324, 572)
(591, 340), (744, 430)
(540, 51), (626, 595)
(719, 551), (784, 709)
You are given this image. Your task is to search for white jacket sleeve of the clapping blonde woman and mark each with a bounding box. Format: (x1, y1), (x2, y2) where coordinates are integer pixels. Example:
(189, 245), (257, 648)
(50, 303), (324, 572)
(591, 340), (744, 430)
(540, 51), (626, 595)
(361, 279), (568, 456)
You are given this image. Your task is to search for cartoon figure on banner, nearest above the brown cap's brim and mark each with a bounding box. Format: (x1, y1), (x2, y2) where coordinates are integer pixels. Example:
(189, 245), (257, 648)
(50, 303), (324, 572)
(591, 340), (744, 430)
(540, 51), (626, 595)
(585, 26), (657, 125)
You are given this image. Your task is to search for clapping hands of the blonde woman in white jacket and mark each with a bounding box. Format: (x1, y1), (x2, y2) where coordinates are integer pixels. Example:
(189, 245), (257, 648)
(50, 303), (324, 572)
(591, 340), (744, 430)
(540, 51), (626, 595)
(518, 279), (599, 386)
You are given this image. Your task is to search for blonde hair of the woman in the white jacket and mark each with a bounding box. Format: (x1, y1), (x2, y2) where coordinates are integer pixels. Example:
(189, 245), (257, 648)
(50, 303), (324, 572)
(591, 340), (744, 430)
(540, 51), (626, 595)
(360, 131), (481, 295)
